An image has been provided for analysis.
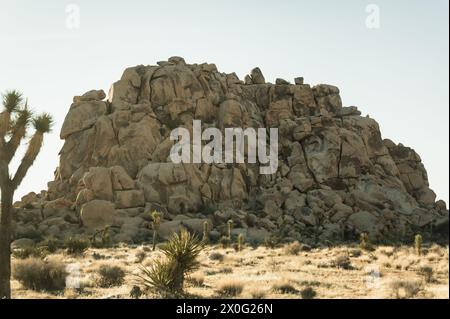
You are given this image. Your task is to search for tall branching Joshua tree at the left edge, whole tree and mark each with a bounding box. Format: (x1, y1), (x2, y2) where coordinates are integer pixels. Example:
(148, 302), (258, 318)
(0, 90), (53, 299)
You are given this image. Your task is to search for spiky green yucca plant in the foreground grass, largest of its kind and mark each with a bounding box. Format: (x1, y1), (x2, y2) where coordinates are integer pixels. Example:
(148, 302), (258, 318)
(138, 230), (203, 294)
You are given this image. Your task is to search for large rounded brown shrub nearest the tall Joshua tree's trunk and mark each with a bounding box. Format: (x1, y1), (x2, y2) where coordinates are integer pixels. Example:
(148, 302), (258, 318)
(12, 258), (67, 291)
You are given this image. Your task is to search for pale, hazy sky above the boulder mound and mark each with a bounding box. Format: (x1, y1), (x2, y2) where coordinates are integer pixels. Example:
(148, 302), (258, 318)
(0, 0), (449, 202)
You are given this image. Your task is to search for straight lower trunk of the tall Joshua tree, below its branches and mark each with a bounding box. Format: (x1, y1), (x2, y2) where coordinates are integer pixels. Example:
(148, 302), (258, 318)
(0, 189), (13, 299)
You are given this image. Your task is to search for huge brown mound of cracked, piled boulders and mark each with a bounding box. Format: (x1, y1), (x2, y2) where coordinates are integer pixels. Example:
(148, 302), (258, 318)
(12, 57), (448, 244)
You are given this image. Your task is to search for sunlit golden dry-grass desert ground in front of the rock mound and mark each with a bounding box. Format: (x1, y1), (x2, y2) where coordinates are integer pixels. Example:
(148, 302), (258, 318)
(12, 243), (449, 299)
